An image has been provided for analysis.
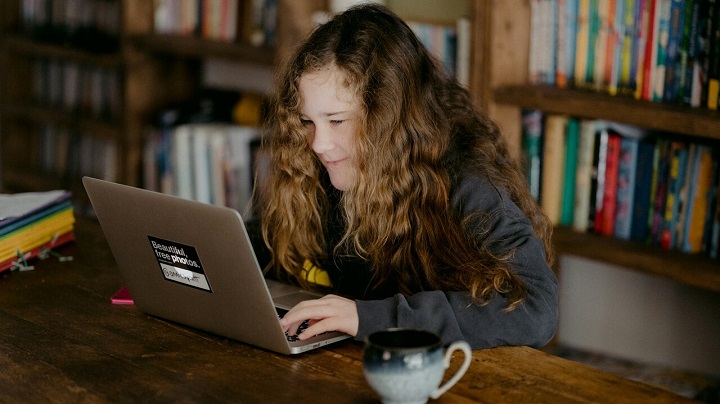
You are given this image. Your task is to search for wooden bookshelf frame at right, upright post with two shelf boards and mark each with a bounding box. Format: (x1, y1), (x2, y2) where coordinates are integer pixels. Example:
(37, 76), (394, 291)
(474, 0), (720, 292)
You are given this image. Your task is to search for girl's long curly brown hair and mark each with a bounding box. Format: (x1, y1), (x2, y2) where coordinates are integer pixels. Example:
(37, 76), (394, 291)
(259, 4), (553, 309)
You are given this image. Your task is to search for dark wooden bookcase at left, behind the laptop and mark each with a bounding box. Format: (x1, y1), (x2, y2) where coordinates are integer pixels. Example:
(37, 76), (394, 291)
(0, 0), (306, 200)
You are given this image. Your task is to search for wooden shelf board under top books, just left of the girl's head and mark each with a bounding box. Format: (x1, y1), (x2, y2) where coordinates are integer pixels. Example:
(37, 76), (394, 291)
(128, 34), (275, 66)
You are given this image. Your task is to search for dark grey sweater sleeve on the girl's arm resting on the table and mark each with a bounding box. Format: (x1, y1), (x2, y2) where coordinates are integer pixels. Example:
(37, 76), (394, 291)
(356, 177), (558, 349)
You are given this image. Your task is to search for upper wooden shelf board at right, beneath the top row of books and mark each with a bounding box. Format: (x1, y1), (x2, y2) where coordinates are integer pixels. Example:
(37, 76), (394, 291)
(494, 85), (720, 139)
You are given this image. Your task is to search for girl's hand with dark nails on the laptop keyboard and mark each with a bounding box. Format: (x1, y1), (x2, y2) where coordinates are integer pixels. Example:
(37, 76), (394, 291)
(280, 295), (359, 340)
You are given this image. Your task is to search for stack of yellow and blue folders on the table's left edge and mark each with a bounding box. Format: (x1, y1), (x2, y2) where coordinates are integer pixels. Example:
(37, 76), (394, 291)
(0, 190), (75, 272)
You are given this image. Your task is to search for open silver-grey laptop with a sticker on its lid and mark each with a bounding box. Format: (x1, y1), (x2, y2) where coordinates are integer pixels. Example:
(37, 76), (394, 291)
(83, 177), (350, 354)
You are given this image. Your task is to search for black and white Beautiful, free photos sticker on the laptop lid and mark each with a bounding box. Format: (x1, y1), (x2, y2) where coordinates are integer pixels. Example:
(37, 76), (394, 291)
(148, 236), (212, 292)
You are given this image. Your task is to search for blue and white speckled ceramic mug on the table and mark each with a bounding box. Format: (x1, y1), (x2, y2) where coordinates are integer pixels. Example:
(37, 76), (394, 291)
(363, 328), (472, 404)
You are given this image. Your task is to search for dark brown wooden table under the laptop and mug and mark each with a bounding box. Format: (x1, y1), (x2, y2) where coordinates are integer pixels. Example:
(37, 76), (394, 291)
(0, 218), (696, 404)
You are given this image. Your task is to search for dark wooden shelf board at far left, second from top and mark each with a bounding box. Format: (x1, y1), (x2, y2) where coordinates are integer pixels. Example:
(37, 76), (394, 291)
(3, 104), (122, 139)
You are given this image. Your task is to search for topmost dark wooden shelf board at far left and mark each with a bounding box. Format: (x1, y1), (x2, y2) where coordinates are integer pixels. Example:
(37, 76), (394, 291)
(0, 35), (123, 68)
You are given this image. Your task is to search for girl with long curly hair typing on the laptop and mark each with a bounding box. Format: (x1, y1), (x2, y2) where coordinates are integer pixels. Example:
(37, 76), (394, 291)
(250, 4), (557, 348)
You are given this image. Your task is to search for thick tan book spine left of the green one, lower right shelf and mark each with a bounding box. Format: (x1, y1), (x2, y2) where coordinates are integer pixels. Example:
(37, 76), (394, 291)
(541, 114), (568, 225)
